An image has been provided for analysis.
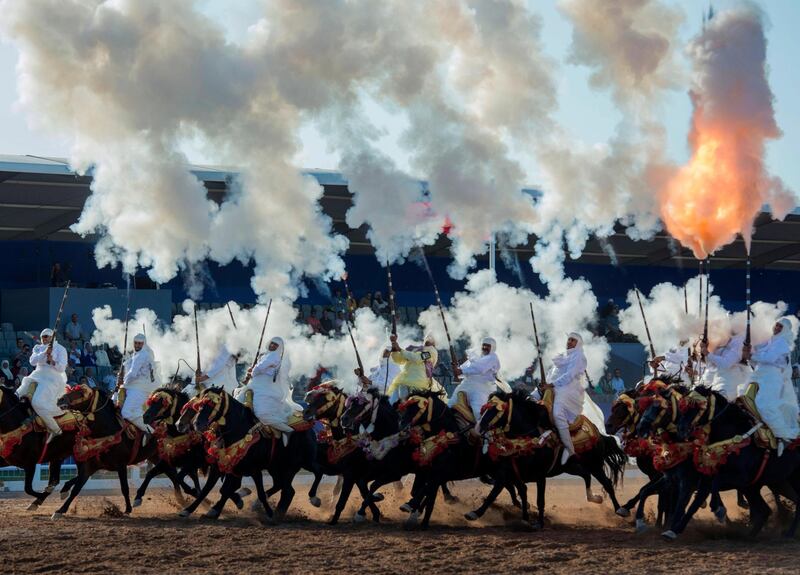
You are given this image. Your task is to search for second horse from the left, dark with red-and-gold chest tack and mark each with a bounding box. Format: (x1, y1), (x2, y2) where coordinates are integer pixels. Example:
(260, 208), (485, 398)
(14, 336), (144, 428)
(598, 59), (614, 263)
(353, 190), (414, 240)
(52, 384), (160, 519)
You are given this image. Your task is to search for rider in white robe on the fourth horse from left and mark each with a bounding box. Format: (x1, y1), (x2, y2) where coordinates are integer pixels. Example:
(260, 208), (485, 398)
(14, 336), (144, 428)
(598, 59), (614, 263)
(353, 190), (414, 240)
(242, 337), (303, 433)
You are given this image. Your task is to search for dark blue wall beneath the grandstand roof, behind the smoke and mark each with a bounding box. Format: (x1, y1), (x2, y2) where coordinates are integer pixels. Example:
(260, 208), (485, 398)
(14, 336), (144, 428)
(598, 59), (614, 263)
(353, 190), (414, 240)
(0, 240), (800, 310)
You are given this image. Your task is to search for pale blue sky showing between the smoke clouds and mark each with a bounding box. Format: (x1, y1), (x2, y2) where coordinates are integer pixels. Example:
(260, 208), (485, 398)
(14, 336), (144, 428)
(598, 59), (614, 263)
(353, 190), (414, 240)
(0, 0), (800, 194)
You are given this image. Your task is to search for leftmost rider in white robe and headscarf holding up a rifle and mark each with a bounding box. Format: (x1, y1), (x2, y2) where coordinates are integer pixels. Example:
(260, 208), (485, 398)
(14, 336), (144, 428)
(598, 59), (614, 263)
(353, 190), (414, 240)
(17, 328), (67, 443)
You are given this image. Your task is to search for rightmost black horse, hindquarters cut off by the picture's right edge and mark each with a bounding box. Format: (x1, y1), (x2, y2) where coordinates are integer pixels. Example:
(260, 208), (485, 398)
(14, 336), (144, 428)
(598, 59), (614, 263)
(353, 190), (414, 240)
(664, 386), (800, 539)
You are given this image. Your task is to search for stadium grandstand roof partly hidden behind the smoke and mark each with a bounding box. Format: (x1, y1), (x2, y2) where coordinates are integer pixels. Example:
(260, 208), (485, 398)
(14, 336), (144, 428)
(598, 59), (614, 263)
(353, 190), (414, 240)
(0, 155), (800, 270)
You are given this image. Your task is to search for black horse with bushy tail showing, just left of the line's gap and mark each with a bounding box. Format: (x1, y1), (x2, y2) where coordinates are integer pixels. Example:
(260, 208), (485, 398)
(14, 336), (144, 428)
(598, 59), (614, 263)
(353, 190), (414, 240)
(467, 390), (627, 528)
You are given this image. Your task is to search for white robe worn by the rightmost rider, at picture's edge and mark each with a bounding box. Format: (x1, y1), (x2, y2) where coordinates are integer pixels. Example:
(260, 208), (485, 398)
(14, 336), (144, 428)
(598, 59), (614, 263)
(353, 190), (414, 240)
(750, 328), (800, 440)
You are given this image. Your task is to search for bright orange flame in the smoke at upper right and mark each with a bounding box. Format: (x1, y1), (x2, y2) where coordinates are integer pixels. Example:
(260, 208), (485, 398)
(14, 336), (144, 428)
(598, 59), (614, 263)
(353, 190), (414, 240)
(661, 127), (762, 259)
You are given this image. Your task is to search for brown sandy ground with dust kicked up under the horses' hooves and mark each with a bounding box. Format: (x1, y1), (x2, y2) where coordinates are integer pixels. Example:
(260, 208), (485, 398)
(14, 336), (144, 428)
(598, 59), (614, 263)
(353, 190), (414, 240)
(0, 477), (800, 575)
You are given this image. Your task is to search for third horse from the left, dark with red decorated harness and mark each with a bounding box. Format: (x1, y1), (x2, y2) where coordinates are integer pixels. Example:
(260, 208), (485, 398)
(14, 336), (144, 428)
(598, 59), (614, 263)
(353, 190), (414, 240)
(133, 387), (244, 509)
